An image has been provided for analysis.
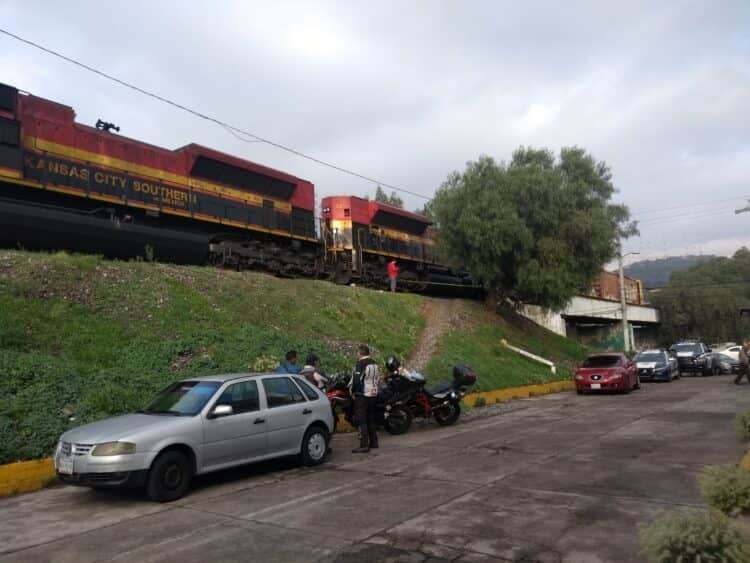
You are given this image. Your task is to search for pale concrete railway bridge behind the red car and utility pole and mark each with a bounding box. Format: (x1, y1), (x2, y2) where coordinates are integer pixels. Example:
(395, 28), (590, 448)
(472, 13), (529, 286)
(522, 295), (659, 350)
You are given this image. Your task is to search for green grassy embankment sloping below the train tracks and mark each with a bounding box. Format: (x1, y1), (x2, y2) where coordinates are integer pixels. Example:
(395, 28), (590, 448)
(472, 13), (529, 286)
(0, 251), (580, 463)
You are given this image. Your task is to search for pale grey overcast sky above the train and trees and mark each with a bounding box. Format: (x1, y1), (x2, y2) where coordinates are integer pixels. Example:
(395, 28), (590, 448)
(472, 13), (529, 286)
(0, 0), (750, 259)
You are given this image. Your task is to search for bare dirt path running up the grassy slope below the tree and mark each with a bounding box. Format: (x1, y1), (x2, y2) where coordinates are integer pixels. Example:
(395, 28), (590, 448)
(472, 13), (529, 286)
(405, 298), (469, 372)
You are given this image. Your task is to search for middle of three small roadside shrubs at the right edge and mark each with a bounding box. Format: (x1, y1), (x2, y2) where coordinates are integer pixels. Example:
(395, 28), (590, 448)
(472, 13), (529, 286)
(698, 464), (750, 516)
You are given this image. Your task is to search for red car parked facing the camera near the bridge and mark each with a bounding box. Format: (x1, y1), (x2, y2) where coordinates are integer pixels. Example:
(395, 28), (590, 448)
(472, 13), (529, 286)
(575, 352), (641, 395)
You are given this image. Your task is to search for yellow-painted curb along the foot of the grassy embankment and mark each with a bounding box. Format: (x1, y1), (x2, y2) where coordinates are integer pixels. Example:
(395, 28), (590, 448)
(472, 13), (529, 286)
(0, 381), (576, 498)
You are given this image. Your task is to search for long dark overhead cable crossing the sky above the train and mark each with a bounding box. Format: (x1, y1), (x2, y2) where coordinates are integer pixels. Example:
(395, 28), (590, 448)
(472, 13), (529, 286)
(0, 28), (432, 201)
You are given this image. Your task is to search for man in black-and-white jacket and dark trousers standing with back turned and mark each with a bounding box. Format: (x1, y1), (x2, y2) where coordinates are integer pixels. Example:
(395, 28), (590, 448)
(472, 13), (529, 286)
(349, 344), (380, 454)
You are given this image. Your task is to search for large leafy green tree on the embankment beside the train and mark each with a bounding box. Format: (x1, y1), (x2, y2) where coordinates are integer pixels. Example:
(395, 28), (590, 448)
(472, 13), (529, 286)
(431, 147), (637, 308)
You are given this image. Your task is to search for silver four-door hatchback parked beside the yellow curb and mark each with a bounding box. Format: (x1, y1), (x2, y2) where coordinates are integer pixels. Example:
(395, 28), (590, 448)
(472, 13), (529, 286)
(54, 373), (334, 502)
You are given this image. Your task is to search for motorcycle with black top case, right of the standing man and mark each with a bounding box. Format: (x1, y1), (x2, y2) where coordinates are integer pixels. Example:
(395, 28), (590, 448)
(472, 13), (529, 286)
(388, 366), (477, 426)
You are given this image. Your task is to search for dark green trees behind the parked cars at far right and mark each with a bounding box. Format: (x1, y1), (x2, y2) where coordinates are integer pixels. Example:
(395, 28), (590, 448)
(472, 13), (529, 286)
(652, 247), (750, 345)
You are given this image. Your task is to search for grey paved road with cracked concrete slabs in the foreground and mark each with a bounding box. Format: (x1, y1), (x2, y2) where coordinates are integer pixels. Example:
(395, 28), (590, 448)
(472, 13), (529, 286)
(0, 377), (750, 563)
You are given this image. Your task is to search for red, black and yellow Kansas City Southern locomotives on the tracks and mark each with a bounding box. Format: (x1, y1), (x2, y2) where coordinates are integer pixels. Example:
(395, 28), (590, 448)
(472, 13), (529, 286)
(0, 84), (481, 296)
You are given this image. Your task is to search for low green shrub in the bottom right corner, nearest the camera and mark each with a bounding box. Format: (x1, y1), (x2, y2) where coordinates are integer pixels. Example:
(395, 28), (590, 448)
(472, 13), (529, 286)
(640, 512), (750, 563)
